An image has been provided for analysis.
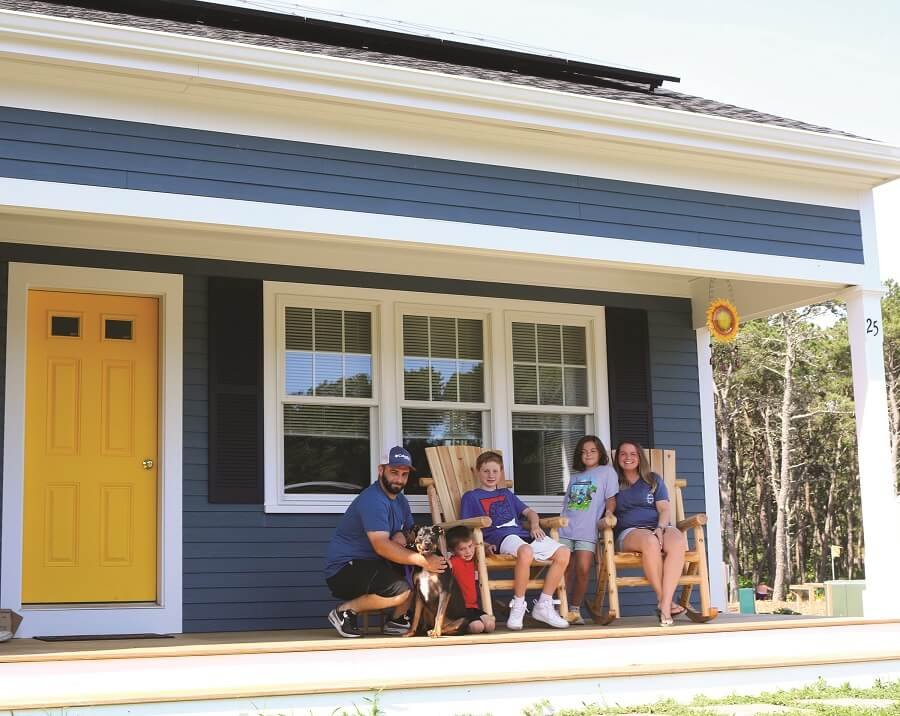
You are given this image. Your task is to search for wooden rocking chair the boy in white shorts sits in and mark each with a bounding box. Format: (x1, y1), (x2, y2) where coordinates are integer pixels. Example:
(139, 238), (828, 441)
(419, 445), (569, 616)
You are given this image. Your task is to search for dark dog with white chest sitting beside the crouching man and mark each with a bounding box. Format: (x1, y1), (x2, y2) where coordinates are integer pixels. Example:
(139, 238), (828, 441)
(404, 525), (465, 639)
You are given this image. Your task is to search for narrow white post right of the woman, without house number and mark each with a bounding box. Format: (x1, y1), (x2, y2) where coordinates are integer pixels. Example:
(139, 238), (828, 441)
(697, 328), (728, 612)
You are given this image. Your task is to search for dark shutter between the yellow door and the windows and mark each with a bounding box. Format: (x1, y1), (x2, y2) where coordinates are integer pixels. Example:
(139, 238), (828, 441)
(209, 277), (263, 504)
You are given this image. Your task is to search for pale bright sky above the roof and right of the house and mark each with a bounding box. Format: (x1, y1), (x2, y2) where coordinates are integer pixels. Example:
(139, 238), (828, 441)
(214, 0), (900, 280)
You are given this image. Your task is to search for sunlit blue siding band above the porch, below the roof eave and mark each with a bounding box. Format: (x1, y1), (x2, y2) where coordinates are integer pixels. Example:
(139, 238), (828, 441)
(0, 108), (863, 263)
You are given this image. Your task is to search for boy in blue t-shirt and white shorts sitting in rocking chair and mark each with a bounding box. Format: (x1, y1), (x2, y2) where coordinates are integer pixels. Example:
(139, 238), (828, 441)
(460, 450), (570, 630)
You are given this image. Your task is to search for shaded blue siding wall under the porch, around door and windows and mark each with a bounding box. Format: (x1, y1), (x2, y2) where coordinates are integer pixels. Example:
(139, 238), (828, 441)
(0, 245), (704, 632)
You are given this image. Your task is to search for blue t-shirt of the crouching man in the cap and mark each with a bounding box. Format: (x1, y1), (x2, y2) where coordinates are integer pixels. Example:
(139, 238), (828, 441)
(325, 482), (413, 577)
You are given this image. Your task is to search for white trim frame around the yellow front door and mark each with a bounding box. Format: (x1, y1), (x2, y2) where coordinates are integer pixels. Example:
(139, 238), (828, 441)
(0, 263), (184, 637)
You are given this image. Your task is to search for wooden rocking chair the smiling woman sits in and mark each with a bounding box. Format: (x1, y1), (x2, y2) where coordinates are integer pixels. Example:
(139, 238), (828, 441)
(588, 450), (719, 624)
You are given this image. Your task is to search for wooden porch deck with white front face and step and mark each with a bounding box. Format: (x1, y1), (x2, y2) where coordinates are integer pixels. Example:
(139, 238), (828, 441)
(0, 614), (900, 716)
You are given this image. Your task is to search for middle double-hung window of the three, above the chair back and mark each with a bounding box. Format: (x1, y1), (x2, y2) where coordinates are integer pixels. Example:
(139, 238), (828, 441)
(400, 308), (490, 494)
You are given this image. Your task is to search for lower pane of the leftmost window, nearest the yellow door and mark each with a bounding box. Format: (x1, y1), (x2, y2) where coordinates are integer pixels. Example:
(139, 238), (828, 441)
(283, 404), (371, 495)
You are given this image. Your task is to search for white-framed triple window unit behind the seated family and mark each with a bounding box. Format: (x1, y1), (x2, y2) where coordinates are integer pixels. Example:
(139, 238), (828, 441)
(263, 282), (609, 512)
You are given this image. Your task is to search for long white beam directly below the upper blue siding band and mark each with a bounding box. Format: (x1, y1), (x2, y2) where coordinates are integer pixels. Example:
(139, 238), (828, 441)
(0, 178), (865, 288)
